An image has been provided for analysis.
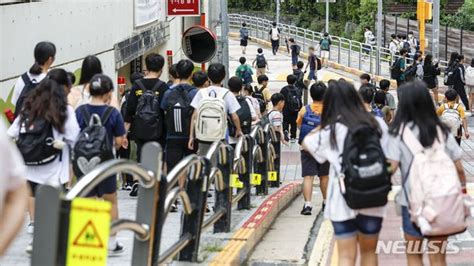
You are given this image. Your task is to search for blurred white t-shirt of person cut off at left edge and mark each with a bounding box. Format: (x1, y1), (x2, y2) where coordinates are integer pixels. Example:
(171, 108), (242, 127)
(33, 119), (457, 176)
(0, 121), (26, 216)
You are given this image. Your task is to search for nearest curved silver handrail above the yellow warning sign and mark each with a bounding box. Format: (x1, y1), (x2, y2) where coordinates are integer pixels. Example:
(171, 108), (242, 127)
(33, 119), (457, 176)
(65, 160), (156, 200)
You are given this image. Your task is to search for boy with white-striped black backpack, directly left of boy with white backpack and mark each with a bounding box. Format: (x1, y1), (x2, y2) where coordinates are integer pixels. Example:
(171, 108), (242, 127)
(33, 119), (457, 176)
(161, 60), (198, 172)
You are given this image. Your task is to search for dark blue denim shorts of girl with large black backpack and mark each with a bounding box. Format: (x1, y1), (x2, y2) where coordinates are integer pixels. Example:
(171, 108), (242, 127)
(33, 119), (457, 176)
(332, 214), (383, 239)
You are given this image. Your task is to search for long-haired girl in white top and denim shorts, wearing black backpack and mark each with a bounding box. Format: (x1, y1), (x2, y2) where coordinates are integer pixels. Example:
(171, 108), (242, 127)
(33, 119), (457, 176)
(303, 80), (387, 265)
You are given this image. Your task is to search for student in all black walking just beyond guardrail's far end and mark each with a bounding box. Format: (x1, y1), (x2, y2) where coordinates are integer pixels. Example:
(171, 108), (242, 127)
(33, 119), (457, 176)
(280, 75), (303, 142)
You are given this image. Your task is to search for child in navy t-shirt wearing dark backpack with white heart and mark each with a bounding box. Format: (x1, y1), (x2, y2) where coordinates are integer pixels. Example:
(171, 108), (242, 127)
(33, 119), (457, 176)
(73, 74), (128, 254)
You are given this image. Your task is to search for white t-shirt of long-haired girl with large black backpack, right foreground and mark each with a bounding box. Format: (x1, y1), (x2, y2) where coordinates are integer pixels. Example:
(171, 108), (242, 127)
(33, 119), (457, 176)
(303, 117), (388, 222)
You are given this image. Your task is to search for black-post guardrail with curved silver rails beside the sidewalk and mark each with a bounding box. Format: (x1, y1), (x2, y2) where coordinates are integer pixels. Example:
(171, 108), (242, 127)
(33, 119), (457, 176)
(31, 125), (280, 266)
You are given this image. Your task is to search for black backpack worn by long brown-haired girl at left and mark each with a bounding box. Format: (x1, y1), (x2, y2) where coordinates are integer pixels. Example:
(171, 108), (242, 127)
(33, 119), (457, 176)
(16, 113), (62, 166)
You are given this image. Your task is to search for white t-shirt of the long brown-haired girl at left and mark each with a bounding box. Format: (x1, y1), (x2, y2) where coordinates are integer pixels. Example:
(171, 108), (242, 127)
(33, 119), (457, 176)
(7, 105), (80, 186)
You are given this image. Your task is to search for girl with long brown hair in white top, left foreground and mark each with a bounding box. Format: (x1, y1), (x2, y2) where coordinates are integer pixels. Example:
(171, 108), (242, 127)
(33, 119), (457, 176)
(7, 78), (80, 233)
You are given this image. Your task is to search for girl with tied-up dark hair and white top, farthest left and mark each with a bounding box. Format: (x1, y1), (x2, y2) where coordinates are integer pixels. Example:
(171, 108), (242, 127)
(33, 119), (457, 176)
(12, 42), (56, 116)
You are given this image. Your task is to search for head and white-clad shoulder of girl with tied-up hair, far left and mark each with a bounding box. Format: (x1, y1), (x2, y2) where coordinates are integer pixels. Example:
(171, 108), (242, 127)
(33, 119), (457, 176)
(12, 42), (56, 105)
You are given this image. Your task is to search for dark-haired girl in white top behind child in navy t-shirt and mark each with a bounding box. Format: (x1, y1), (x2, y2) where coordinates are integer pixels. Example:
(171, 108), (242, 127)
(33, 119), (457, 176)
(67, 55), (119, 109)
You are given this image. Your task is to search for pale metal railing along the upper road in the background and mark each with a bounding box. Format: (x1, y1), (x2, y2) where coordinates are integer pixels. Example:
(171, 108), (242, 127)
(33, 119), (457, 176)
(229, 14), (447, 78)
